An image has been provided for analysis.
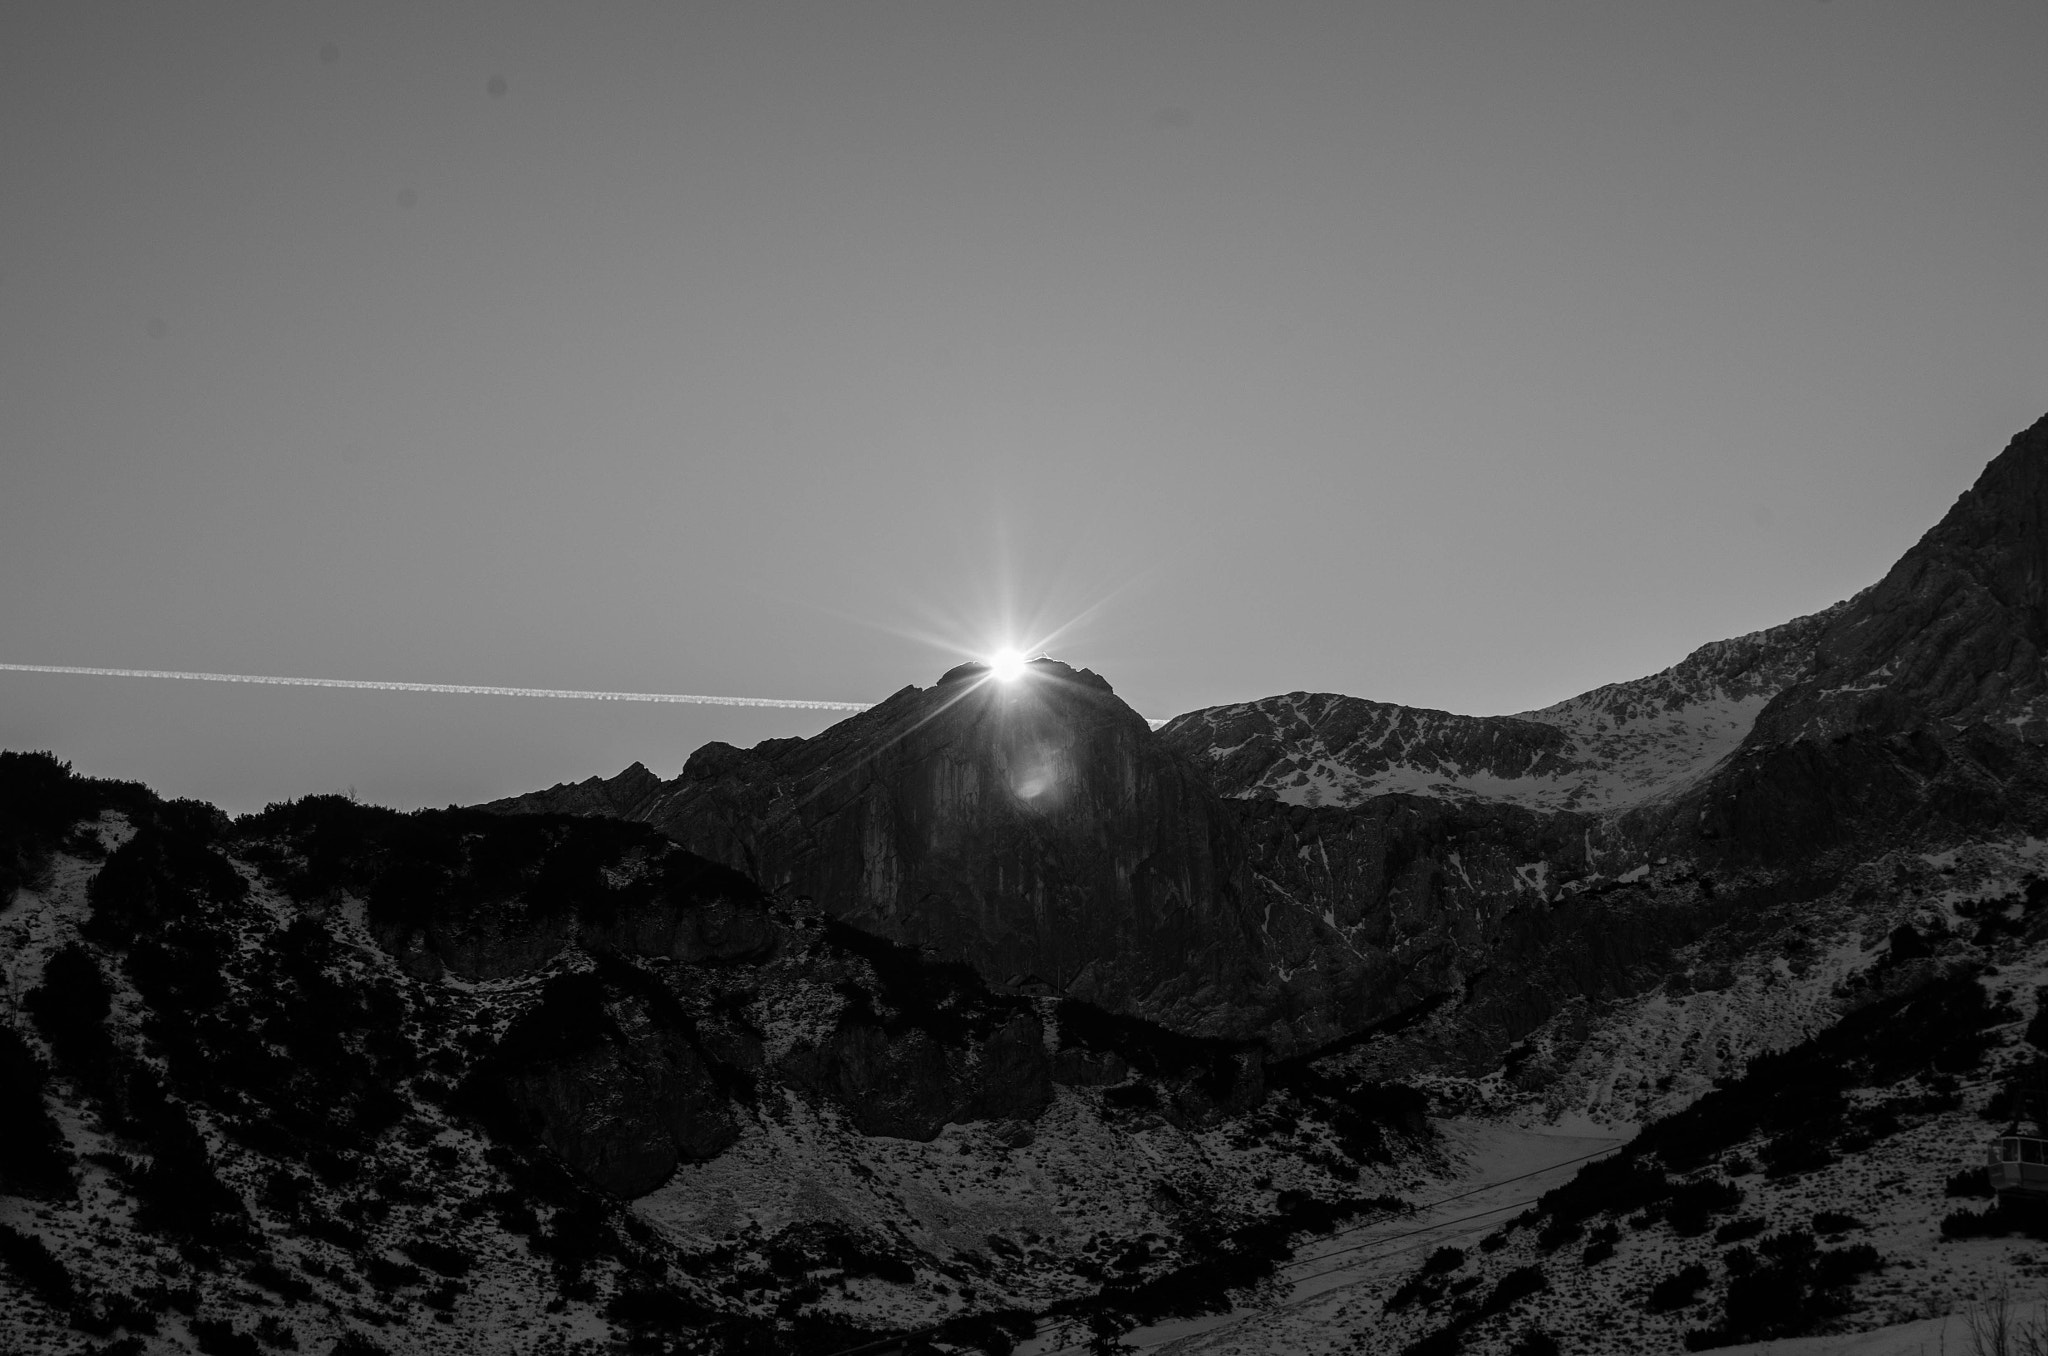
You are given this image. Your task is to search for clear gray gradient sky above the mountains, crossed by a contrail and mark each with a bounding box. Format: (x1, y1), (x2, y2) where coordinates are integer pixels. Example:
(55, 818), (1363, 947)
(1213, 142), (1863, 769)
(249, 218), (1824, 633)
(0, 0), (2048, 809)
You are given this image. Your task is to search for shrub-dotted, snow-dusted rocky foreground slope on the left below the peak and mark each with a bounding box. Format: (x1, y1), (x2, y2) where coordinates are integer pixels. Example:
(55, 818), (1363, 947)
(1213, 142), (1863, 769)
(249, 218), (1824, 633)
(0, 754), (1434, 1356)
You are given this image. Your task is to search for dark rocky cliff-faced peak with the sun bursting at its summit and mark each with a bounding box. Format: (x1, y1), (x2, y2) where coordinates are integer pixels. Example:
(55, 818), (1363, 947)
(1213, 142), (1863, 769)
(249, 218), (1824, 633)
(512, 660), (1286, 1041)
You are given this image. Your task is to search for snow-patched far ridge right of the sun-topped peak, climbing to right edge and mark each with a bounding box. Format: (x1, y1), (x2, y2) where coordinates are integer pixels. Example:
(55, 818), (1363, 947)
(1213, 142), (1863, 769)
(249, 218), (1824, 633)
(1161, 409), (2048, 815)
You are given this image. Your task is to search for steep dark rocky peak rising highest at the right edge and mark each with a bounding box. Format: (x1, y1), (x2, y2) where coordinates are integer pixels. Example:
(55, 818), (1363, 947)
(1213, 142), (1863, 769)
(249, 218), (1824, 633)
(1632, 409), (2048, 866)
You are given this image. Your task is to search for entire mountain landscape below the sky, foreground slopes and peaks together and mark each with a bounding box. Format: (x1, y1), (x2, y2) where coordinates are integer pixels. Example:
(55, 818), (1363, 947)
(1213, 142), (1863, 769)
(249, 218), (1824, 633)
(12, 420), (2048, 1356)
